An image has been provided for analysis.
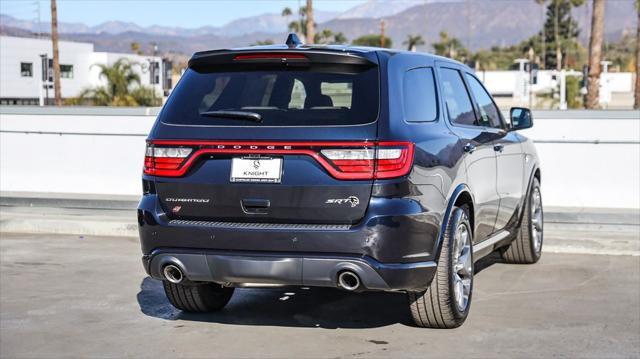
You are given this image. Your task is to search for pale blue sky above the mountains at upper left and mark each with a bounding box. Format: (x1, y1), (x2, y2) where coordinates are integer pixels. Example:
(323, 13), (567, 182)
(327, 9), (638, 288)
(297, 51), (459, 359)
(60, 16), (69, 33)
(0, 0), (364, 28)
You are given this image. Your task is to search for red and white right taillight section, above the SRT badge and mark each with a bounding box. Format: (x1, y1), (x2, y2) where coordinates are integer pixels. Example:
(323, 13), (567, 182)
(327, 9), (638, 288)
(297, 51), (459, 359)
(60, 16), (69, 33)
(320, 142), (413, 179)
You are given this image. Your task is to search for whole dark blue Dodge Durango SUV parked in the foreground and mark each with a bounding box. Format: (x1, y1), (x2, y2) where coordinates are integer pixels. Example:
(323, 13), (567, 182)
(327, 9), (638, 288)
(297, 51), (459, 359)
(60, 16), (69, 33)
(138, 36), (543, 328)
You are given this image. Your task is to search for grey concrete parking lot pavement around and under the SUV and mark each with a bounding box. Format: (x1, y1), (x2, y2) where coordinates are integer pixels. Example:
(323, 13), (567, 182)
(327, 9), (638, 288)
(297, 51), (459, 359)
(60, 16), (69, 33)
(0, 233), (640, 358)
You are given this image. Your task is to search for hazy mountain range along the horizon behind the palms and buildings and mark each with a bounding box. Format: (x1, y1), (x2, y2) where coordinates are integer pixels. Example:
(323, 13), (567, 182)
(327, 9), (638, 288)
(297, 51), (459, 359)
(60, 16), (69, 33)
(0, 0), (637, 55)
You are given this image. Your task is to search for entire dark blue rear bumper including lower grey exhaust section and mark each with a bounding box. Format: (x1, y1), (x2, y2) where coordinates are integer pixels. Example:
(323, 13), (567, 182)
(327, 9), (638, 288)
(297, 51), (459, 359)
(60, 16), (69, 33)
(138, 194), (441, 290)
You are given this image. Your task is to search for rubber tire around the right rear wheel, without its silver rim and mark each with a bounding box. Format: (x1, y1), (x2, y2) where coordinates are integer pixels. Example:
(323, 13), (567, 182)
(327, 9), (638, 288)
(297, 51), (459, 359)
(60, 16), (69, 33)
(408, 207), (473, 329)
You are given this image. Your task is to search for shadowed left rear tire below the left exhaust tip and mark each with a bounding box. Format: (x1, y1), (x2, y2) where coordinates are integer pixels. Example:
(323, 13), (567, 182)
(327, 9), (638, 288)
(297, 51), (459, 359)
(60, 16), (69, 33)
(162, 280), (234, 313)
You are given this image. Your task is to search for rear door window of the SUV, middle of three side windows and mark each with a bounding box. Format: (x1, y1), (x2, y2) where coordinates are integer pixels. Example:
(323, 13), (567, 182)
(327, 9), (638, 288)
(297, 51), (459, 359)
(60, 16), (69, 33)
(440, 68), (476, 126)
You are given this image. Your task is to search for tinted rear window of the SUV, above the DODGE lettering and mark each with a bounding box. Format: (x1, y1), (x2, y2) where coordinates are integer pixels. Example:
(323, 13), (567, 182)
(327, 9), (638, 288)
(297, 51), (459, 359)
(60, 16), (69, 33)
(161, 67), (379, 126)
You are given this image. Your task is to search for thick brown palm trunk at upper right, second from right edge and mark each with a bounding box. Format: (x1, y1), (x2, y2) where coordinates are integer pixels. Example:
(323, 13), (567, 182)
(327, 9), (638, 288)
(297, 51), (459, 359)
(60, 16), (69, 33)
(585, 0), (604, 109)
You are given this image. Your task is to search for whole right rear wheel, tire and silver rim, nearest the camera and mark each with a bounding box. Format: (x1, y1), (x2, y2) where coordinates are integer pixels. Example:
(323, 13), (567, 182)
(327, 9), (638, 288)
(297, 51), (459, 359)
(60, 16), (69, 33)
(408, 207), (473, 329)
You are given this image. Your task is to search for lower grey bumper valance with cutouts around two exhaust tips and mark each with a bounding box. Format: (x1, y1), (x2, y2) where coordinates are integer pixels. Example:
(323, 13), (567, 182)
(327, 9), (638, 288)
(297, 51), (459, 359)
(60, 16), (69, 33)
(143, 249), (436, 290)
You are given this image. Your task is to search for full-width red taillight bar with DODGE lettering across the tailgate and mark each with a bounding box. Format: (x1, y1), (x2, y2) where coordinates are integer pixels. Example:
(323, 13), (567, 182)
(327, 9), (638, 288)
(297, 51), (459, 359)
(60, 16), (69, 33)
(144, 140), (413, 180)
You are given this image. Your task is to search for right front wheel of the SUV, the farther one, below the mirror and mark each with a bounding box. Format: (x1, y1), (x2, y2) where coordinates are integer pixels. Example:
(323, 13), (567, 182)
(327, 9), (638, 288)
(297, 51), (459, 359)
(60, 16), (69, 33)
(502, 178), (544, 264)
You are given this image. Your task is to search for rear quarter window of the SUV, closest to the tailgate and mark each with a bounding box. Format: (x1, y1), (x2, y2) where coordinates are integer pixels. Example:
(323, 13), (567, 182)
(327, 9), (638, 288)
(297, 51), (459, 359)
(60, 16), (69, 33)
(402, 67), (438, 122)
